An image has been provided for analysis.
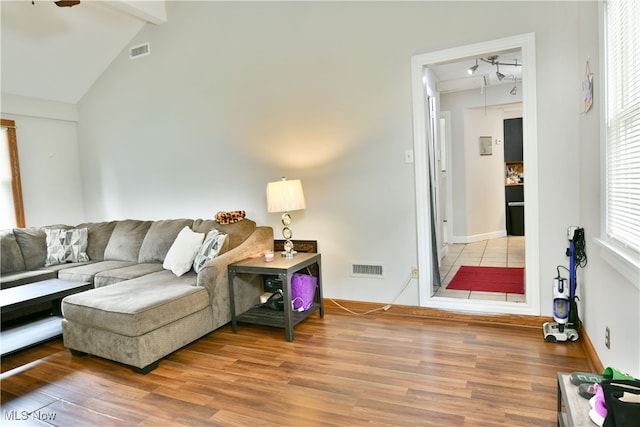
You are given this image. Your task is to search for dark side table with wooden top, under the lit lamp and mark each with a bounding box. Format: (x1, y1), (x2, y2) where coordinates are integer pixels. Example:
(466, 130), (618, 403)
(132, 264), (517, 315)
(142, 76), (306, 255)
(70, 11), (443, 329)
(228, 253), (324, 341)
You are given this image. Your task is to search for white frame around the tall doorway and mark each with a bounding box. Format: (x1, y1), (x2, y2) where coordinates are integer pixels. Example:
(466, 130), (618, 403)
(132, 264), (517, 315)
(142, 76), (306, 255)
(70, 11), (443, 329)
(411, 33), (540, 315)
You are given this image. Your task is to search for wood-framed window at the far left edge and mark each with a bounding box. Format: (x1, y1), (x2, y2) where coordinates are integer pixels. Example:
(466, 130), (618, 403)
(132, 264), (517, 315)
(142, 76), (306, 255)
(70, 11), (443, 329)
(0, 119), (25, 229)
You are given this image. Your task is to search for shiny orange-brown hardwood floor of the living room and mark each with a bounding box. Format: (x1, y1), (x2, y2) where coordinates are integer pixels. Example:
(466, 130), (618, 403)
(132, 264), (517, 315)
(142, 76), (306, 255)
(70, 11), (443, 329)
(0, 302), (590, 426)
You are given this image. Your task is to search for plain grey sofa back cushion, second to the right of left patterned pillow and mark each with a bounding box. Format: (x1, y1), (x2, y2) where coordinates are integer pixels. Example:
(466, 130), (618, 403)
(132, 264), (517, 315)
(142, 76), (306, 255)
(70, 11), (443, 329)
(104, 219), (152, 262)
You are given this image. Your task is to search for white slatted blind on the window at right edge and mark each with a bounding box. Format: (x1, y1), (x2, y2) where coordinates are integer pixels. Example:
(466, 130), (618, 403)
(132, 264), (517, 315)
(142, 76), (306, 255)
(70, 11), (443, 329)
(605, 0), (640, 254)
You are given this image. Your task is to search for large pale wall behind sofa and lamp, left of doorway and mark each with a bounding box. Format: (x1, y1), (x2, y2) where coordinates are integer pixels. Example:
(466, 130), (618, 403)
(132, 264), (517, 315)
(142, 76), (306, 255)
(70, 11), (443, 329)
(79, 2), (428, 304)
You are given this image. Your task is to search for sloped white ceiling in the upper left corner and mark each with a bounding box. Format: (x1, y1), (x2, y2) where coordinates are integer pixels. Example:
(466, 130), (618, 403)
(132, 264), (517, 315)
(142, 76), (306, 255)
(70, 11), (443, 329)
(0, 0), (166, 104)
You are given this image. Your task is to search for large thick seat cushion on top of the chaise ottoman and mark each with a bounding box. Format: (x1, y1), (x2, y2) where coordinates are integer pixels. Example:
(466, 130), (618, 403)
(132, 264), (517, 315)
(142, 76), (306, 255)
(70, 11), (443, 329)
(62, 271), (204, 337)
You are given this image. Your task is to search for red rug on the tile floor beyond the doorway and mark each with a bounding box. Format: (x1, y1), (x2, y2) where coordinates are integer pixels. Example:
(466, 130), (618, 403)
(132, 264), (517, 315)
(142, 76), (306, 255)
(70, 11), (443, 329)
(447, 265), (524, 294)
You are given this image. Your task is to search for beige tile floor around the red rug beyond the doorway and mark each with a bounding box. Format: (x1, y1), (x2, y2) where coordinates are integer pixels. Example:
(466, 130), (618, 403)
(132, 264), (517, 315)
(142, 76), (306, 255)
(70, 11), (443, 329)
(436, 236), (526, 302)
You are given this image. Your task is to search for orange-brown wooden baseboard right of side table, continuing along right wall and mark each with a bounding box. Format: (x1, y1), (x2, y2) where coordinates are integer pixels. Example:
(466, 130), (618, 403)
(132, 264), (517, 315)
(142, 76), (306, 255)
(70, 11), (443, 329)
(324, 298), (604, 373)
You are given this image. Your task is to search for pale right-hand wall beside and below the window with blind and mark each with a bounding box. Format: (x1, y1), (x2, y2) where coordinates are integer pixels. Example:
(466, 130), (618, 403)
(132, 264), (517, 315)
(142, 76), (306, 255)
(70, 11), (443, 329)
(573, 4), (640, 377)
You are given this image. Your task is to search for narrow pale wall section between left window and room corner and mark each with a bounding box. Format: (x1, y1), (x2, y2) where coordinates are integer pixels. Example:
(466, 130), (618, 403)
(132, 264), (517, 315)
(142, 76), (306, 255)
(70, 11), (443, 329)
(1, 94), (84, 227)
